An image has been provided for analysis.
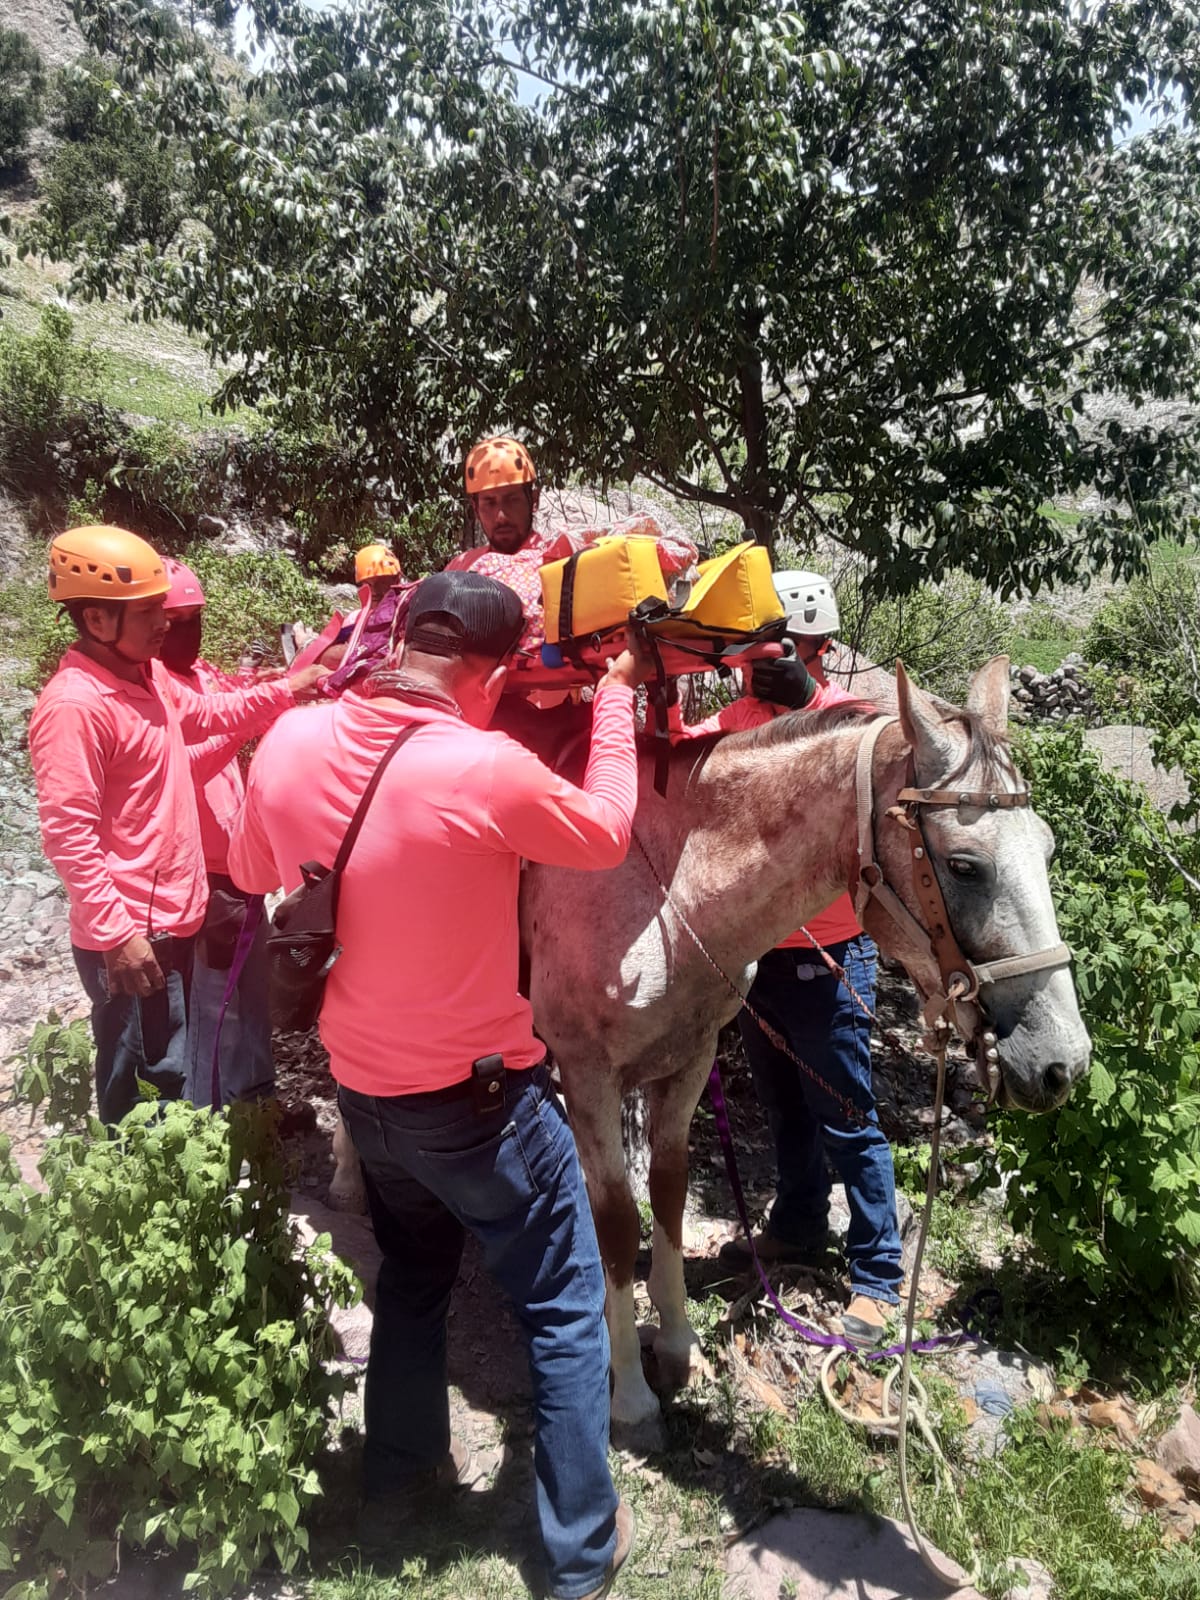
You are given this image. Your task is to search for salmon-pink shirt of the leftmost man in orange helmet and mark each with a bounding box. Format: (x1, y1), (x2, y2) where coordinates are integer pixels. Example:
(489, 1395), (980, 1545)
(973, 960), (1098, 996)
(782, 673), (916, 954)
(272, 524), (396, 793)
(29, 645), (294, 950)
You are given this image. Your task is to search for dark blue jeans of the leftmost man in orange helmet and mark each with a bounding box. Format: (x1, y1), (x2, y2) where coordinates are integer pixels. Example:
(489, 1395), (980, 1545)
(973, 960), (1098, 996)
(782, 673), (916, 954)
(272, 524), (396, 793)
(70, 936), (195, 1125)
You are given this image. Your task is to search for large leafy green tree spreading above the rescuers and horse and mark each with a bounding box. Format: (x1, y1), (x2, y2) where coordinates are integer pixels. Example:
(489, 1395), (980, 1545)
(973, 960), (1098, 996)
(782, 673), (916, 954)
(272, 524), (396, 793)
(47, 0), (1200, 590)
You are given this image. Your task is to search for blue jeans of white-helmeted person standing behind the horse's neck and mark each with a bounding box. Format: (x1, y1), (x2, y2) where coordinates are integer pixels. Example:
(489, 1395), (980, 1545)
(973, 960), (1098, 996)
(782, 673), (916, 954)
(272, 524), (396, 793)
(739, 934), (904, 1306)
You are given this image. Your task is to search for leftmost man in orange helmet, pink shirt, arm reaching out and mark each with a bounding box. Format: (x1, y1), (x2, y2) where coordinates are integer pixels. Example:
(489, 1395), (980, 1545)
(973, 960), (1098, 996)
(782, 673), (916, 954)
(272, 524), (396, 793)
(29, 526), (323, 1123)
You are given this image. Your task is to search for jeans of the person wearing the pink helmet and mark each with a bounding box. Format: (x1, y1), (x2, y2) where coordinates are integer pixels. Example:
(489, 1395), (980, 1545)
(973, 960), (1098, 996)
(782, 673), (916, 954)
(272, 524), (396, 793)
(184, 896), (275, 1107)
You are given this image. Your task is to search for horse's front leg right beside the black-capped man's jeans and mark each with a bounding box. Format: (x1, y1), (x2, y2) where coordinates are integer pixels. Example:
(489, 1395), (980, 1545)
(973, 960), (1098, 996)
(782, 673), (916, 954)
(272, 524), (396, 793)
(566, 1074), (667, 1453)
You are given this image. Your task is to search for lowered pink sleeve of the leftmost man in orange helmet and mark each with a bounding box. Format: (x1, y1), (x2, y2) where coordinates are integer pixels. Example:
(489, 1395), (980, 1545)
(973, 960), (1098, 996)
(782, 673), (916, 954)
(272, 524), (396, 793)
(29, 699), (141, 950)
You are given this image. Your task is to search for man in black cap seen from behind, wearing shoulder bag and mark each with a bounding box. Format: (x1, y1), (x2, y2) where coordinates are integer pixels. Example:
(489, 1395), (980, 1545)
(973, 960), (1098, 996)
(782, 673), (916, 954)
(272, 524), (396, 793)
(230, 573), (640, 1600)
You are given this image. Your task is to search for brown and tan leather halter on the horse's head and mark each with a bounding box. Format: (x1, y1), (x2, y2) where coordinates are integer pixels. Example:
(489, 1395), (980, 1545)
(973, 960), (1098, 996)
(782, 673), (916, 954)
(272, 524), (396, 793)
(854, 717), (1070, 1099)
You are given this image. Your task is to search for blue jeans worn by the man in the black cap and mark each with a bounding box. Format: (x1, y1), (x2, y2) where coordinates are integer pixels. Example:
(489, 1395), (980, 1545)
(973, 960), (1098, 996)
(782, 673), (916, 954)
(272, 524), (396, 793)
(338, 1066), (616, 1600)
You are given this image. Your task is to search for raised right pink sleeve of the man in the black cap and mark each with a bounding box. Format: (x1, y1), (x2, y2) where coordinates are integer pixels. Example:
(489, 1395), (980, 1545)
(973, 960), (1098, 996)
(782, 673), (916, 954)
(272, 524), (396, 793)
(488, 683), (637, 872)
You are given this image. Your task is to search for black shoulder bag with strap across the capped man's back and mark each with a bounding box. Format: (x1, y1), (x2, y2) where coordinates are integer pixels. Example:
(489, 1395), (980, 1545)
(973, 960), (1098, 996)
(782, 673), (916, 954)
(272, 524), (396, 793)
(267, 722), (421, 1029)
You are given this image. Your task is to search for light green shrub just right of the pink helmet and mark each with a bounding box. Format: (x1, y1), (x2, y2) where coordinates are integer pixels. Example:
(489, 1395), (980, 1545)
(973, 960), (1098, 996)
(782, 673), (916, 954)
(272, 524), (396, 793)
(182, 542), (330, 670)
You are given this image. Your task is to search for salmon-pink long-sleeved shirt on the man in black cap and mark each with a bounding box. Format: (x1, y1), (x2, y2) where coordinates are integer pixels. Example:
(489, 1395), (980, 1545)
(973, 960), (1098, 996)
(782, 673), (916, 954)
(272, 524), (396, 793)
(229, 685), (637, 1096)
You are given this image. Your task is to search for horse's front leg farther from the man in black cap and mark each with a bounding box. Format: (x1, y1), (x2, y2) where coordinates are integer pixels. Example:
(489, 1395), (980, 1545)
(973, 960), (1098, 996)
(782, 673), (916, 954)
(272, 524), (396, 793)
(645, 1072), (712, 1389)
